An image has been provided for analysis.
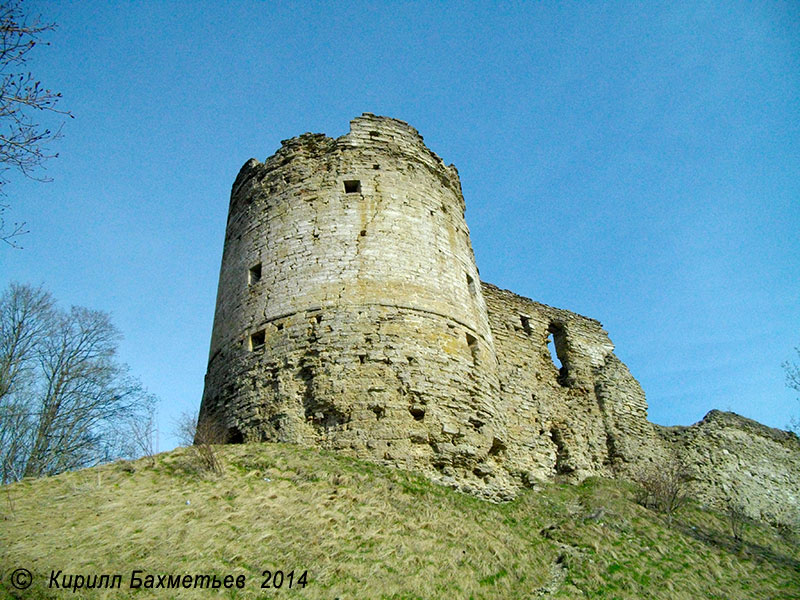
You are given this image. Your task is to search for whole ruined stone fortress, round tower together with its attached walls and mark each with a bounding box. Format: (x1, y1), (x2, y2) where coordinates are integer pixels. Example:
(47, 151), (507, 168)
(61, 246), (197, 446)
(201, 114), (800, 516)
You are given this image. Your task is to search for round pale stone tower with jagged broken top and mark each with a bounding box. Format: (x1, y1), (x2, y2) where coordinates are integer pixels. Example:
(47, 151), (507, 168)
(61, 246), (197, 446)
(200, 114), (504, 488)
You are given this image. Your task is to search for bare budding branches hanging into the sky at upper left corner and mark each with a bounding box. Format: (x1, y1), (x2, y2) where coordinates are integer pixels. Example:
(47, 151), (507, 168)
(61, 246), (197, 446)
(0, 0), (72, 246)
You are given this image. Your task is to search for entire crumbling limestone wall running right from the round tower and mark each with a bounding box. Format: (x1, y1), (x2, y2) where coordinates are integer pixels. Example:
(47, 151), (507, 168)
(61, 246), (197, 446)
(483, 284), (800, 527)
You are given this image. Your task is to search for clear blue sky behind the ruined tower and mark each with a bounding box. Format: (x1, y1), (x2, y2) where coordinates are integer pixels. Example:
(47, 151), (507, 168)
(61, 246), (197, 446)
(0, 0), (800, 450)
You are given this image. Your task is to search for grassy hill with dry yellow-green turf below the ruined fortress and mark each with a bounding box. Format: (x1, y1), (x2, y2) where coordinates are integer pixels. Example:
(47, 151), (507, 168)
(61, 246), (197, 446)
(0, 444), (800, 600)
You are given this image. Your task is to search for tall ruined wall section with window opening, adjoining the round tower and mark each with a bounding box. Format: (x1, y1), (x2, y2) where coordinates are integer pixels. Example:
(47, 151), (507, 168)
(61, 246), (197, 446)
(483, 284), (661, 480)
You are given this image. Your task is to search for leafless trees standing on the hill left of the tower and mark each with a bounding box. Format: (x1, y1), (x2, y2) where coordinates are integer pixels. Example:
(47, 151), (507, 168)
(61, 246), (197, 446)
(0, 284), (154, 483)
